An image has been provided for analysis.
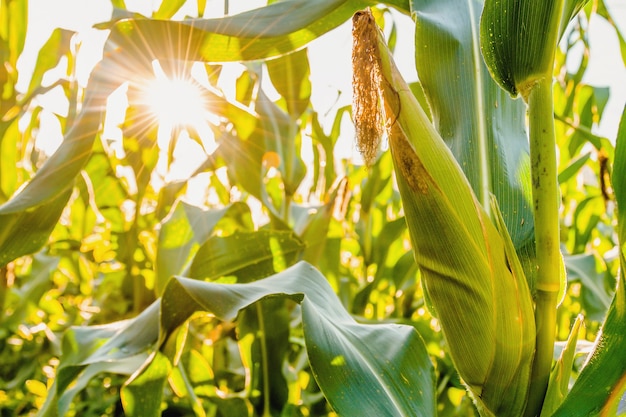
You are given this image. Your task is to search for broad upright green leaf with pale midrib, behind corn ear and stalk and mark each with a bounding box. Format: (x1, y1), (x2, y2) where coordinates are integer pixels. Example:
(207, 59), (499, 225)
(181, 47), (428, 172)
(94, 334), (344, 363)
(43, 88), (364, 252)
(412, 0), (534, 280)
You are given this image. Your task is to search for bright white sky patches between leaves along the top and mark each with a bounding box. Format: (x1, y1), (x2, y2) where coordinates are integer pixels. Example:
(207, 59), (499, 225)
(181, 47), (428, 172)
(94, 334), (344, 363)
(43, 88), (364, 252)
(19, 0), (626, 165)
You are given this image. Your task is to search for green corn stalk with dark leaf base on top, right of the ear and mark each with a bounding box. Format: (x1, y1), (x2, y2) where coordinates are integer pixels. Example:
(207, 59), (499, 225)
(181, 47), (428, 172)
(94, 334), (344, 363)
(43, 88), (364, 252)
(480, 0), (585, 417)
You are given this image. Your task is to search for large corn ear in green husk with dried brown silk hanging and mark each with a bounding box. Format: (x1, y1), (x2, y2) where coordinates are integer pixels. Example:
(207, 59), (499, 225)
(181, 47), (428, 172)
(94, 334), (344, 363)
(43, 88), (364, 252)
(353, 11), (535, 416)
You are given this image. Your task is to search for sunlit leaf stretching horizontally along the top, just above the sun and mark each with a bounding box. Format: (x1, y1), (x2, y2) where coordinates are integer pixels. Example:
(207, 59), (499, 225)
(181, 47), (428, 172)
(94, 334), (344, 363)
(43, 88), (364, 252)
(109, 0), (408, 62)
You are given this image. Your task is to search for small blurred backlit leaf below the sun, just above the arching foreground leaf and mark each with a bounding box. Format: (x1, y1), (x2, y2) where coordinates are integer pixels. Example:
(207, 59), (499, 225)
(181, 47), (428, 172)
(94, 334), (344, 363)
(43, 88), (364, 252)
(155, 201), (248, 294)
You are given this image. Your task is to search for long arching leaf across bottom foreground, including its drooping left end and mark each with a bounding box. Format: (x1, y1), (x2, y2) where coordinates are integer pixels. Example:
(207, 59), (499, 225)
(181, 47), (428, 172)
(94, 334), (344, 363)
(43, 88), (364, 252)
(41, 262), (436, 417)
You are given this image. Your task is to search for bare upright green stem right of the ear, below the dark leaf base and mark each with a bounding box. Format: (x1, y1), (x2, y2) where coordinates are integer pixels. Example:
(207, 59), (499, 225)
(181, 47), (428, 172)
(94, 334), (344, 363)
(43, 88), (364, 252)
(525, 77), (561, 417)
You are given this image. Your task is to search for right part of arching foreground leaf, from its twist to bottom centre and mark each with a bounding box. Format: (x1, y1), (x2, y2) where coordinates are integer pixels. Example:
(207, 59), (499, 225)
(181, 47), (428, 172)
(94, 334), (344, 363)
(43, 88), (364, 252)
(161, 263), (435, 417)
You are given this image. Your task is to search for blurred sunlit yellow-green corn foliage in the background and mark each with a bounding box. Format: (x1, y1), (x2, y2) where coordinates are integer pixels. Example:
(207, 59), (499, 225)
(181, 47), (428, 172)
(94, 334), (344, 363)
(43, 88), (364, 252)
(0, 0), (626, 417)
